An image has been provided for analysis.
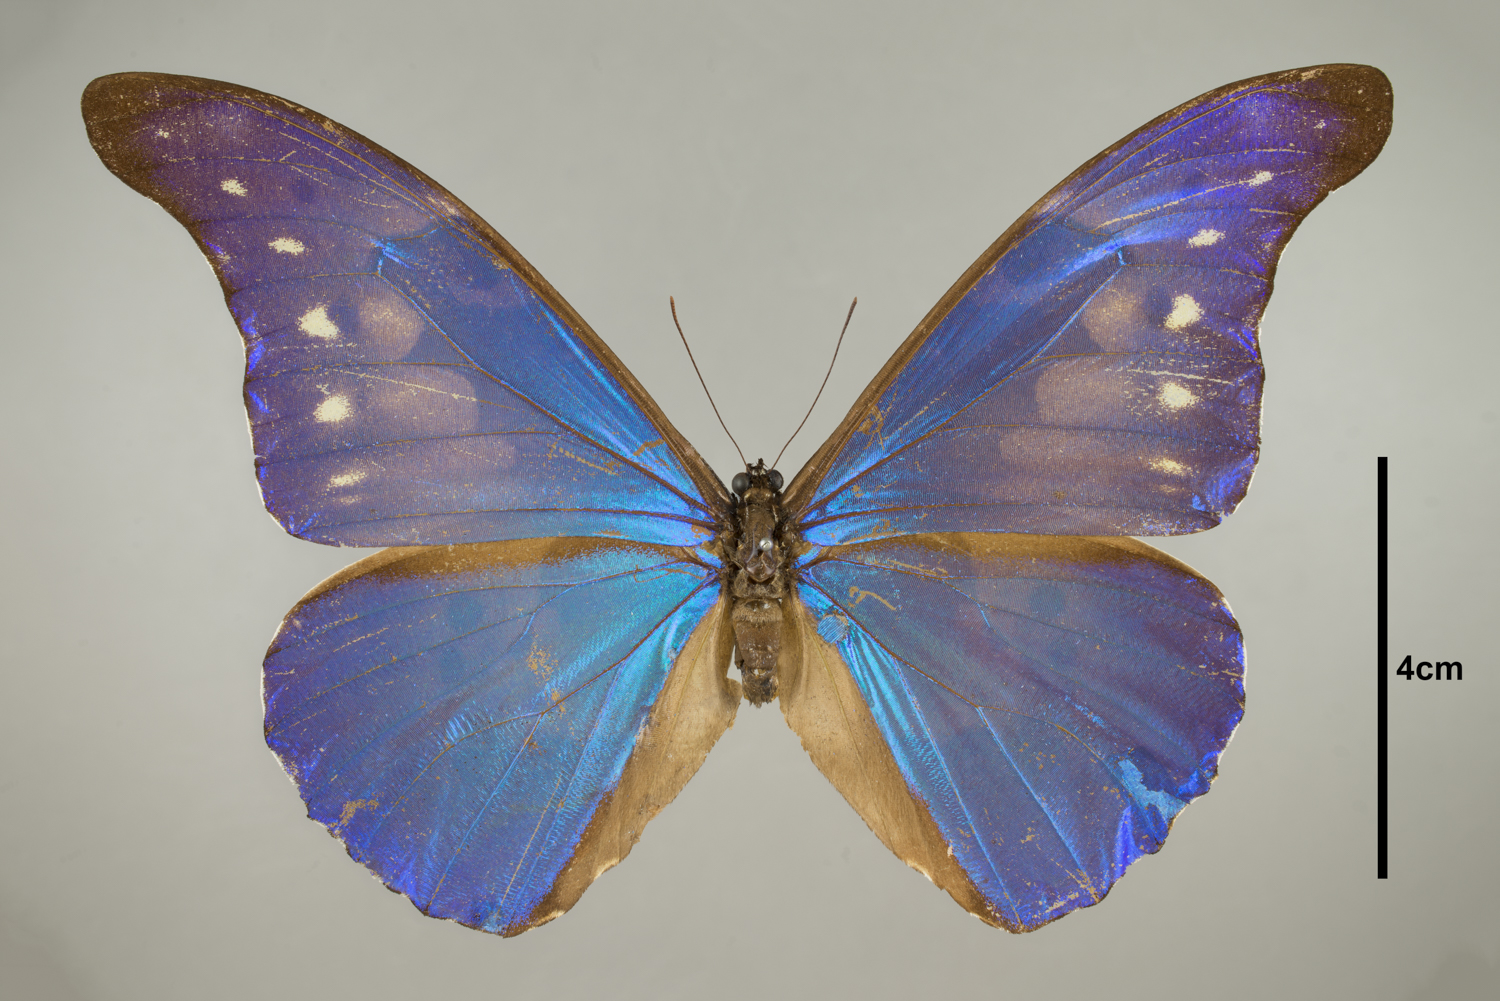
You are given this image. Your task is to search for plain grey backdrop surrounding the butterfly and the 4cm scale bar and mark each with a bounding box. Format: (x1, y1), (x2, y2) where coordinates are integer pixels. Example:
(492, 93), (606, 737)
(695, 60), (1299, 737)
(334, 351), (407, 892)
(0, 0), (1500, 999)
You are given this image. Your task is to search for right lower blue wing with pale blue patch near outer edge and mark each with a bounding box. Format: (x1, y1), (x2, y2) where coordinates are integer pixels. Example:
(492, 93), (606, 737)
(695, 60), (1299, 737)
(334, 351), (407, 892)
(782, 533), (1245, 932)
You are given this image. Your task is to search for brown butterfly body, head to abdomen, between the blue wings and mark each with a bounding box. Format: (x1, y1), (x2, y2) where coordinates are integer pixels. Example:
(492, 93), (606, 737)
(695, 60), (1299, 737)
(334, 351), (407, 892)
(725, 461), (795, 705)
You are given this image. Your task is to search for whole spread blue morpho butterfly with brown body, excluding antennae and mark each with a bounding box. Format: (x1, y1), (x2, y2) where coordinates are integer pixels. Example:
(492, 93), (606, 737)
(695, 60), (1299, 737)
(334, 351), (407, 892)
(83, 66), (1391, 935)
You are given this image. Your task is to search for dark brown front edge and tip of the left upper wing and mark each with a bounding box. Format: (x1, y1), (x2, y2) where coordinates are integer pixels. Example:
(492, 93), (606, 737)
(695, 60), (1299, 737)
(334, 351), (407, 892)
(83, 72), (732, 521)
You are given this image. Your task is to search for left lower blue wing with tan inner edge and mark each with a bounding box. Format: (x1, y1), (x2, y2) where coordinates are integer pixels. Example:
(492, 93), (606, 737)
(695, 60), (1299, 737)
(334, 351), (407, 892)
(266, 539), (740, 935)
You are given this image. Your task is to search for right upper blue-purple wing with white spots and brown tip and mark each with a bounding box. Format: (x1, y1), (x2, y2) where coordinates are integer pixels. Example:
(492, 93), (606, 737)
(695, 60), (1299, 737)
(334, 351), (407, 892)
(786, 66), (1391, 545)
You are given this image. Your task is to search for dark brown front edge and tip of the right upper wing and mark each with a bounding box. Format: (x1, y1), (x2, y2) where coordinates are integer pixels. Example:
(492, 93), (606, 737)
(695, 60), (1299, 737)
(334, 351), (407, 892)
(785, 63), (1391, 515)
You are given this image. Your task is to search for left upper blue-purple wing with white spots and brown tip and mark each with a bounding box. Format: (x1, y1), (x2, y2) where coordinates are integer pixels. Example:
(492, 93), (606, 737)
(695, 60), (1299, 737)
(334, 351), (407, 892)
(83, 74), (729, 546)
